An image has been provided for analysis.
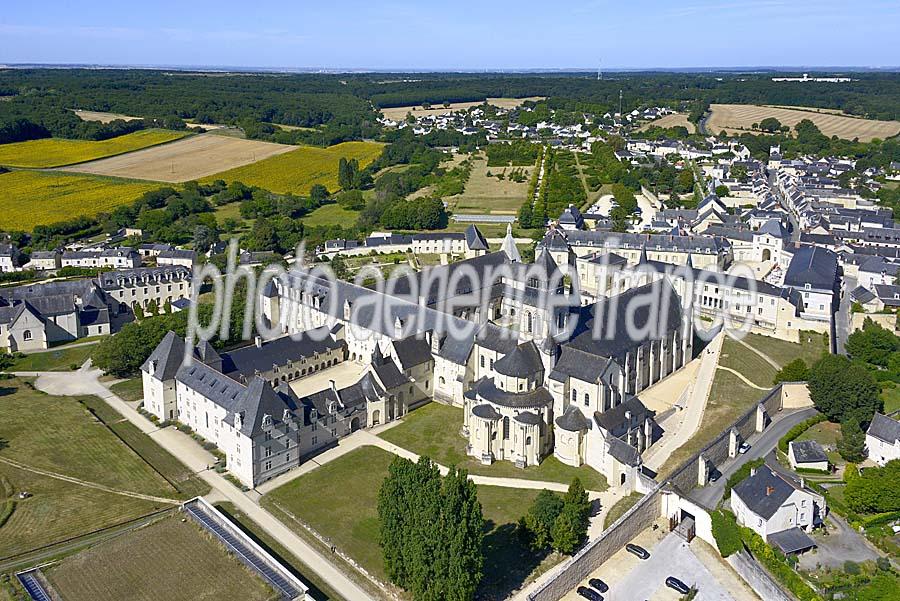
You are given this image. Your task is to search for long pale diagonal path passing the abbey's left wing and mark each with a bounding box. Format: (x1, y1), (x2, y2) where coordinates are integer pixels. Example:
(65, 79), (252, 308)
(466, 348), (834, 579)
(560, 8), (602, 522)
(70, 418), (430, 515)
(24, 367), (373, 601)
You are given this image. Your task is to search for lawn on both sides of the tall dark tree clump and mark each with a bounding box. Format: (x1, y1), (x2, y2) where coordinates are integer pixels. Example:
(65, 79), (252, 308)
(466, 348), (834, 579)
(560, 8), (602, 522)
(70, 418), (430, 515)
(262, 446), (561, 598)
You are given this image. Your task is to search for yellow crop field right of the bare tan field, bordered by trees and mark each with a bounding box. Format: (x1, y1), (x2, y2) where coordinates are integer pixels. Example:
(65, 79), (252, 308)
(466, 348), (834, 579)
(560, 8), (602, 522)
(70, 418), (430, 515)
(203, 140), (384, 195)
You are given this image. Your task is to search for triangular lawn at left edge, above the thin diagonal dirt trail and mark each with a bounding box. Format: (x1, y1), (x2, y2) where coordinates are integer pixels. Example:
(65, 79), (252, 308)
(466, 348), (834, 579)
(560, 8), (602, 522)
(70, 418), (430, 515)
(0, 380), (175, 497)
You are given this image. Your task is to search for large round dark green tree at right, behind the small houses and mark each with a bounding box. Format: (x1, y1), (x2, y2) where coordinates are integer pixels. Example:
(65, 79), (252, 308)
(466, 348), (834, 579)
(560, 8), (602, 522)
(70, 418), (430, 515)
(809, 355), (881, 424)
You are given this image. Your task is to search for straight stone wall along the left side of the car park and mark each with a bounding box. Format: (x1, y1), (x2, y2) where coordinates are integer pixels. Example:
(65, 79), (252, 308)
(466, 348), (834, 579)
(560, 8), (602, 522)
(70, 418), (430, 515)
(528, 484), (662, 601)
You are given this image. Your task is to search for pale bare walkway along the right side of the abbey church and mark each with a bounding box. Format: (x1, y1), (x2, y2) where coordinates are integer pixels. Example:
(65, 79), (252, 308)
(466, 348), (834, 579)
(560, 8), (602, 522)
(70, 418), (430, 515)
(643, 333), (725, 471)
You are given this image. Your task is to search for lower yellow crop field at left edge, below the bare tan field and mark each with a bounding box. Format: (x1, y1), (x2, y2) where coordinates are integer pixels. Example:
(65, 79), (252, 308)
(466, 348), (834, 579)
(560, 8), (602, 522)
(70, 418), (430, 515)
(0, 171), (159, 231)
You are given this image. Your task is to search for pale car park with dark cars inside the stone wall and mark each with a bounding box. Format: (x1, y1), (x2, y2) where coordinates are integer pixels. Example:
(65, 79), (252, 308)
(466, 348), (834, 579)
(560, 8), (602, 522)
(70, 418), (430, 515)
(563, 521), (758, 601)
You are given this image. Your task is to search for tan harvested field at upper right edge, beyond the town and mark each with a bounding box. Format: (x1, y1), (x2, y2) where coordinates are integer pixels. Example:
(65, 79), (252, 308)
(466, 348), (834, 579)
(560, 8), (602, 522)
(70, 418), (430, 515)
(706, 104), (900, 142)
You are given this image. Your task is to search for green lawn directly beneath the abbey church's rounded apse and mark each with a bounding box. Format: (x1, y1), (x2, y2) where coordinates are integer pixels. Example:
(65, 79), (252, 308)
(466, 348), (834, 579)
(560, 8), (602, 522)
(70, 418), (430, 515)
(379, 402), (607, 491)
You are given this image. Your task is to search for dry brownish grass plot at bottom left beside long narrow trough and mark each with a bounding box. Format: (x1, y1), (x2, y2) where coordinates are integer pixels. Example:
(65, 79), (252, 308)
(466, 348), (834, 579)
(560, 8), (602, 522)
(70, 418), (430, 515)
(43, 517), (278, 601)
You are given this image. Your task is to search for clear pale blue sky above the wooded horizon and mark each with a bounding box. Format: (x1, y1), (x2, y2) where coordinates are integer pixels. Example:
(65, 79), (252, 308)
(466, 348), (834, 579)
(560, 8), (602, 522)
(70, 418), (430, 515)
(0, 0), (900, 69)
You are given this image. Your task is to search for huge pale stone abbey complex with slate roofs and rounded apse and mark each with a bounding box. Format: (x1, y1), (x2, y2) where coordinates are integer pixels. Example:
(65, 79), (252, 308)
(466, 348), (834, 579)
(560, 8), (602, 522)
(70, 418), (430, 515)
(143, 226), (693, 486)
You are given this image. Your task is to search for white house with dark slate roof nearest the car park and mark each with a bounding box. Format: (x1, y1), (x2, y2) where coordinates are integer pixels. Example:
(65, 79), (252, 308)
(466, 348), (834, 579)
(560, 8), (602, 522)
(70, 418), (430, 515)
(731, 465), (826, 553)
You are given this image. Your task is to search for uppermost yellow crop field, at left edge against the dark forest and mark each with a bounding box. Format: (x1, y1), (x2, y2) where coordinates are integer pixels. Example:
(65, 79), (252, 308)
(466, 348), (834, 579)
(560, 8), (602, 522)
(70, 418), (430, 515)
(0, 129), (187, 168)
